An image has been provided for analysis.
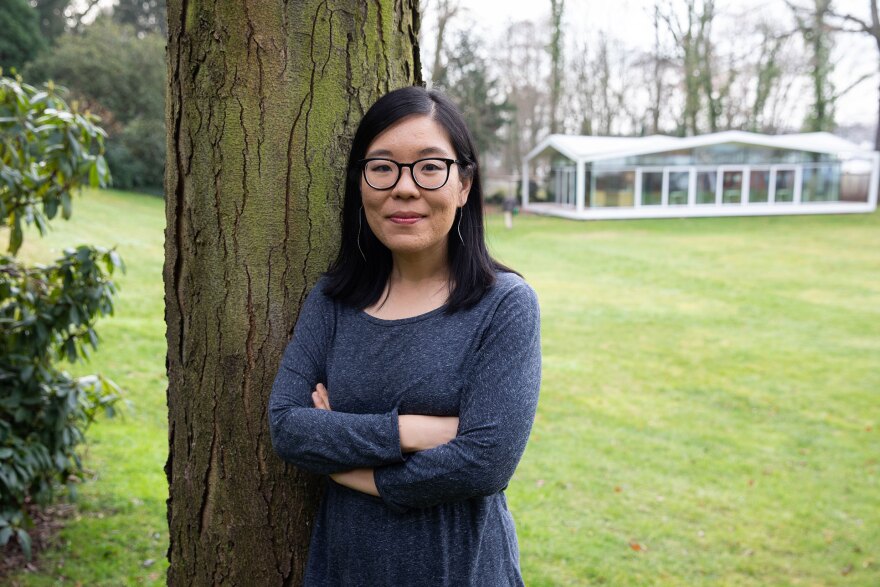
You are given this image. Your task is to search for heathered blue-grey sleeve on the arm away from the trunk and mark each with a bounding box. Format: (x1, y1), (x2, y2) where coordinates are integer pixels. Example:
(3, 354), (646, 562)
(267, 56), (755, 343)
(374, 282), (541, 512)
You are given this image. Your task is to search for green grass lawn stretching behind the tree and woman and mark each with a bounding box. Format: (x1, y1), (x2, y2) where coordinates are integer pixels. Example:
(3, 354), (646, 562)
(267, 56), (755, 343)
(1, 192), (880, 587)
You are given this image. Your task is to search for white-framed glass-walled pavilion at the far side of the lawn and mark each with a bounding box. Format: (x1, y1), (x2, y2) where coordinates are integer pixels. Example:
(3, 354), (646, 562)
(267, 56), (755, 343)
(522, 131), (880, 219)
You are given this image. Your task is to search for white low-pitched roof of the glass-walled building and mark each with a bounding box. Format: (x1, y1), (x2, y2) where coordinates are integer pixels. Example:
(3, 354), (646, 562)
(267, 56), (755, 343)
(526, 130), (871, 161)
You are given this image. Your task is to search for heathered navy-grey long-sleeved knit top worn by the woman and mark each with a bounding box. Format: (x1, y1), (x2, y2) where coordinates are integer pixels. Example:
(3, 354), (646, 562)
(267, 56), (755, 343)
(269, 273), (541, 587)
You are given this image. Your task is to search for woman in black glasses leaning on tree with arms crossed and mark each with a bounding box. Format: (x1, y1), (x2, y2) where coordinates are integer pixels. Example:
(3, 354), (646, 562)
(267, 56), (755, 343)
(269, 87), (541, 586)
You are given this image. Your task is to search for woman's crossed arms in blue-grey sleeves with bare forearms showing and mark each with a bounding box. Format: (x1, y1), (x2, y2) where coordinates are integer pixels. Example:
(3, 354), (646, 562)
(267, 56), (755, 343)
(269, 286), (540, 511)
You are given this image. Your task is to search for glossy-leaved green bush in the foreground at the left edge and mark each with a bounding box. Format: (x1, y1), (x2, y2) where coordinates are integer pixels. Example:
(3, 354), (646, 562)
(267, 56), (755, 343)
(0, 77), (124, 556)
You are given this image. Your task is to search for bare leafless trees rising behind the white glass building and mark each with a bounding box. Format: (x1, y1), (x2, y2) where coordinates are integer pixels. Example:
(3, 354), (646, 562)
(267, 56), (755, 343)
(425, 0), (880, 174)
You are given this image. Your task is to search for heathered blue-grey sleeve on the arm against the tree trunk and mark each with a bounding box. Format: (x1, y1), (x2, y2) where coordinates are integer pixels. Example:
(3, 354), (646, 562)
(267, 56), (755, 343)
(269, 282), (404, 474)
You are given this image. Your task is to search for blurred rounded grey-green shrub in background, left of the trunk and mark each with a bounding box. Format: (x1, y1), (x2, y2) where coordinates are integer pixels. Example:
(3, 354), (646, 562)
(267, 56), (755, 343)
(24, 18), (166, 191)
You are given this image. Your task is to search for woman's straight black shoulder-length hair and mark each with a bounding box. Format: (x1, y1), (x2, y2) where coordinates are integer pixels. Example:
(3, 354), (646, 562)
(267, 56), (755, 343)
(324, 86), (516, 313)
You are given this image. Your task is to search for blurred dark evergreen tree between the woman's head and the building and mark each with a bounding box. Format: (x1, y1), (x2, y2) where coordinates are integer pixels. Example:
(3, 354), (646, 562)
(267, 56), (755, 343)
(435, 31), (512, 154)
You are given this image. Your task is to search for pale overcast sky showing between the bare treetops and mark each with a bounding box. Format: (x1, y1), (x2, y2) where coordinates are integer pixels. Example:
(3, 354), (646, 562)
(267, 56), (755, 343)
(421, 0), (880, 125)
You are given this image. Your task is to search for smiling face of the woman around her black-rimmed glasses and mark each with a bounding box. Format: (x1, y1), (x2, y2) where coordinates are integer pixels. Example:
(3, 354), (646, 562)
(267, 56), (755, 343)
(361, 115), (471, 255)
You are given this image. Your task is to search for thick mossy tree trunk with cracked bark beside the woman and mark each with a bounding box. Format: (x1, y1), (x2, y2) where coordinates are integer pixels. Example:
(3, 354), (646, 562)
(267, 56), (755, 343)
(163, 0), (421, 586)
